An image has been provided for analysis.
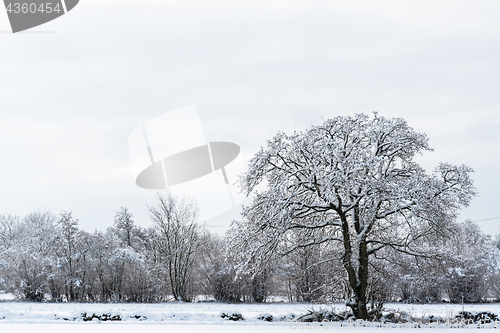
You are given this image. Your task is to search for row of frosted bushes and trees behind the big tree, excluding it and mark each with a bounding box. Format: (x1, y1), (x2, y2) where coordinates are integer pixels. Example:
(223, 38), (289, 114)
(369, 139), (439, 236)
(0, 196), (500, 308)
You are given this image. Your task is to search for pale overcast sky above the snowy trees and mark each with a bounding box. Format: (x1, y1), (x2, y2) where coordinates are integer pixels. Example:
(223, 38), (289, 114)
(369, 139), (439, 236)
(0, 0), (500, 234)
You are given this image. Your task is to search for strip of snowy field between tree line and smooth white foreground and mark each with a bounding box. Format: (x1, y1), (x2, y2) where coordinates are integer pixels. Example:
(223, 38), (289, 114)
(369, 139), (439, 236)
(0, 302), (500, 323)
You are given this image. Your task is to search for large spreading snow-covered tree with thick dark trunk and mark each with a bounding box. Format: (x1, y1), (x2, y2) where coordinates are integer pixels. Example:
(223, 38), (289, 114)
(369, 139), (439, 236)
(232, 113), (475, 319)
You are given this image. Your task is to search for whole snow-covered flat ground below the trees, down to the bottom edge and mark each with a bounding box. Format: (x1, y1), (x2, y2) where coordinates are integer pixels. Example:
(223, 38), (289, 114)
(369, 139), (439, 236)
(0, 302), (500, 333)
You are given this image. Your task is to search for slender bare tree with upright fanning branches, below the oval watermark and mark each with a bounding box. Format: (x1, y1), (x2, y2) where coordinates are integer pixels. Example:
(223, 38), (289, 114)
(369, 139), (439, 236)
(148, 194), (203, 301)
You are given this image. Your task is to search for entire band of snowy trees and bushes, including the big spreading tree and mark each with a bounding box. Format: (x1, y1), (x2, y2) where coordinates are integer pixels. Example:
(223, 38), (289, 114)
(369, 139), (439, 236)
(0, 113), (500, 319)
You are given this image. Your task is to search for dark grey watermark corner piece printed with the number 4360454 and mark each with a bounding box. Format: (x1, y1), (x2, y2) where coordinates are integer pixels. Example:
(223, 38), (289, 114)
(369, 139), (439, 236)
(3, 0), (79, 33)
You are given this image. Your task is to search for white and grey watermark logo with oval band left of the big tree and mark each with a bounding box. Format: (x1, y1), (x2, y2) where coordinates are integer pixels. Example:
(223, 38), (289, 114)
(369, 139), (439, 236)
(128, 105), (244, 220)
